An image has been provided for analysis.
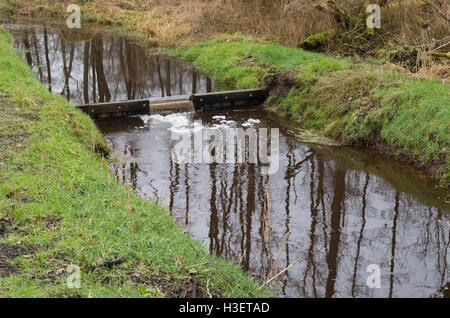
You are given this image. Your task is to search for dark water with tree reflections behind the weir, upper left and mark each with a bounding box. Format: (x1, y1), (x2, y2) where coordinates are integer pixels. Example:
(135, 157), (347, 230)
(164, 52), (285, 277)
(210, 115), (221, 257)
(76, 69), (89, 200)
(4, 24), (215, 104)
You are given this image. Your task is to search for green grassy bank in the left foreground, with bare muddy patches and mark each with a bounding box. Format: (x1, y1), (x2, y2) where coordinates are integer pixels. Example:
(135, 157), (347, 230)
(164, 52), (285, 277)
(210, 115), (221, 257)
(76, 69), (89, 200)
(0, 28), (268, 297)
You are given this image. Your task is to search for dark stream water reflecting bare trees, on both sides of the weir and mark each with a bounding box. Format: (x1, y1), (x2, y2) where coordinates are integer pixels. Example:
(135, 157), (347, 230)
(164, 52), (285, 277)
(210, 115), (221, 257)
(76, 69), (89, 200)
(7, 25), (450, 297)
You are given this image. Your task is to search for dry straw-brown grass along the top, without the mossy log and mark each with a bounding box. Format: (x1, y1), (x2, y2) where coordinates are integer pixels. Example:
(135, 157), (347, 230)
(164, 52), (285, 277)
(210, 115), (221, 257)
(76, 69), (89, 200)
(4, 0), (450, 74)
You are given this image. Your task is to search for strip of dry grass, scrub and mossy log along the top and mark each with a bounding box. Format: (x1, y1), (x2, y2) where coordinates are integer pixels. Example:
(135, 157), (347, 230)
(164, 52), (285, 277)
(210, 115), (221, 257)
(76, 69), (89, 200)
(0, 0), (450, 79)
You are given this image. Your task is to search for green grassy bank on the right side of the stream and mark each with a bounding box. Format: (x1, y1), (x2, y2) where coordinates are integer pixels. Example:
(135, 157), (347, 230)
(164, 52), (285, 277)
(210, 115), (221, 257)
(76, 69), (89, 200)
(169, 34), (450, 183)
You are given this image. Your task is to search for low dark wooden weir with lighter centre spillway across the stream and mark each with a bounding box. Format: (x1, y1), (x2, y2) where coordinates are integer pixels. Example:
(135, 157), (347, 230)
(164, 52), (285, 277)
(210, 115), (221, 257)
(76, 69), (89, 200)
(77, 88), (266, 118)
